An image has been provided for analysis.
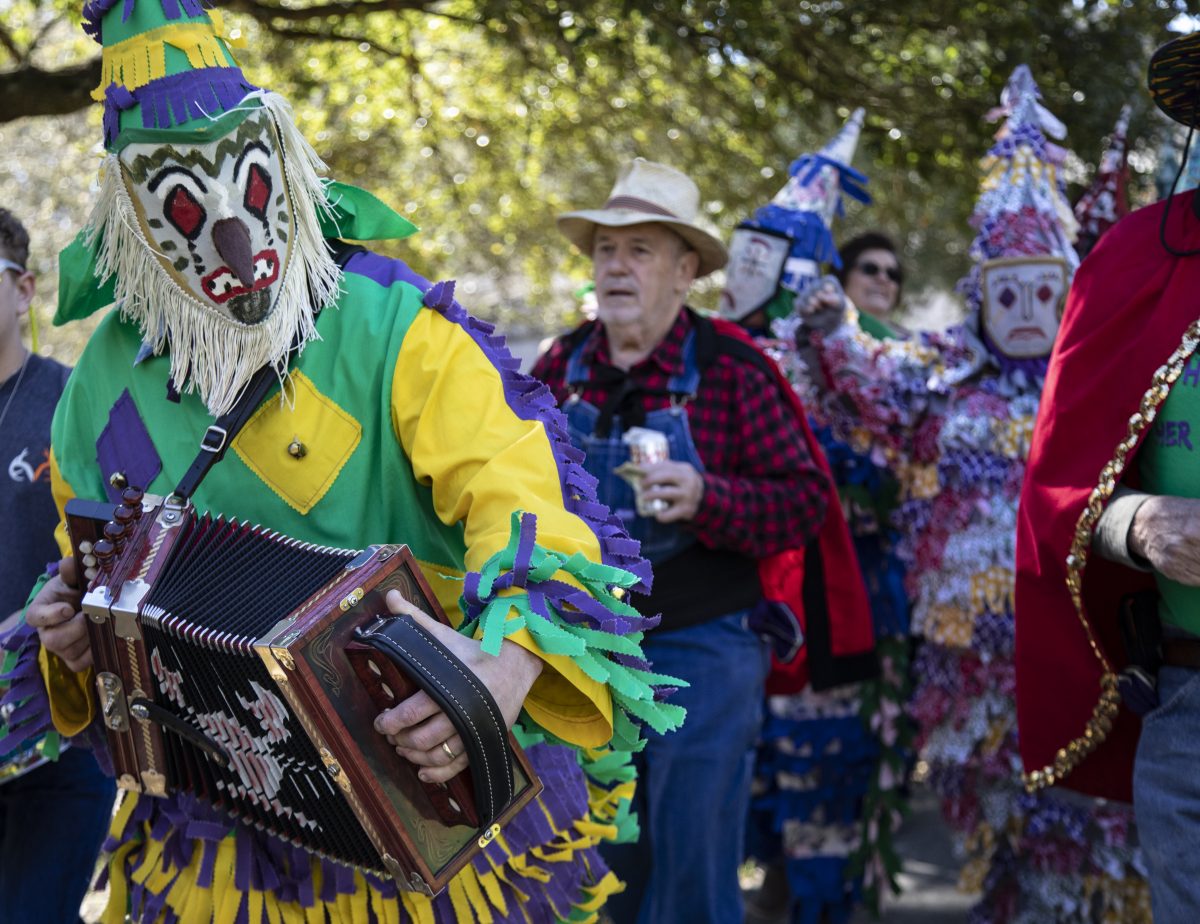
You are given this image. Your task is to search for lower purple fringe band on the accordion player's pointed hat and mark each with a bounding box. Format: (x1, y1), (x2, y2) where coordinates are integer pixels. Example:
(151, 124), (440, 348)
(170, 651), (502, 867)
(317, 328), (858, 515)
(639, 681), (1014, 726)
(103, 67), (258, 148)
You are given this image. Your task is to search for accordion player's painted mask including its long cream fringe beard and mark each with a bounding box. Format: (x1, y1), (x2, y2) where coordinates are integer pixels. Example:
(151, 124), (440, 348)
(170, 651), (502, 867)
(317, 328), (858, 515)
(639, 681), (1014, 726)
(86, 92), (341, 415)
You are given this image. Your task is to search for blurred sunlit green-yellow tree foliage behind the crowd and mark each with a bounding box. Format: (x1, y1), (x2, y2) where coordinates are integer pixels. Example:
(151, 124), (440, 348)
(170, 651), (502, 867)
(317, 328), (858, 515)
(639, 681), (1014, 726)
(0, 0), (1195, 361)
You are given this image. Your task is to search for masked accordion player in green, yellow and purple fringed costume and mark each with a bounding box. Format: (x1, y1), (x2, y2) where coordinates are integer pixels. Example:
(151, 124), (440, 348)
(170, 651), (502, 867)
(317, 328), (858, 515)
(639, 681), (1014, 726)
(4, 0), (682, 923)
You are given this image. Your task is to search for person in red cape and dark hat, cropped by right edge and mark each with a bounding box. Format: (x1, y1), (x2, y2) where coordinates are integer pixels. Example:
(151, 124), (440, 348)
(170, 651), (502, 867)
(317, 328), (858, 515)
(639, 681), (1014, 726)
(1016, 32), (1200, 924)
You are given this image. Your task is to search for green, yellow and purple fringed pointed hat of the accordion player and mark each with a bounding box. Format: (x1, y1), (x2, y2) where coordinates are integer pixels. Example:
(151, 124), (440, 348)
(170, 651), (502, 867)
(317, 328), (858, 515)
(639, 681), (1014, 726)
(83, 0), (258, 151)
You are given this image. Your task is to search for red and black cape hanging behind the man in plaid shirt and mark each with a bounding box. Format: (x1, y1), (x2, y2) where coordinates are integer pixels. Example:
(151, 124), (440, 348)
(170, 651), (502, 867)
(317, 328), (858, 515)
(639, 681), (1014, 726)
(713, 318), (877, 694)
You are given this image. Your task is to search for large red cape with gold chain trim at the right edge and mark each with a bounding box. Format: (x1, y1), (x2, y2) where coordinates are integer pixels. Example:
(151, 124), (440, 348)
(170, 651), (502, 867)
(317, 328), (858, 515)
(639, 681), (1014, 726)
(1016, 193), (1200, 802)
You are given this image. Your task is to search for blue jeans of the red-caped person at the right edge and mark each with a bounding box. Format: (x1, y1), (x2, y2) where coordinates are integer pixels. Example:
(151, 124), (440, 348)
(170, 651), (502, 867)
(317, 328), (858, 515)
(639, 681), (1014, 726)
(1133, 667), (1200, 924)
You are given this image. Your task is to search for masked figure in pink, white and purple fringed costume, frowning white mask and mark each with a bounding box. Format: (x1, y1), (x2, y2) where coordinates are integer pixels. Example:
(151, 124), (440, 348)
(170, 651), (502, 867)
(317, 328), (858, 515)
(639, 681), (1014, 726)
(806, 65), (1147, 922)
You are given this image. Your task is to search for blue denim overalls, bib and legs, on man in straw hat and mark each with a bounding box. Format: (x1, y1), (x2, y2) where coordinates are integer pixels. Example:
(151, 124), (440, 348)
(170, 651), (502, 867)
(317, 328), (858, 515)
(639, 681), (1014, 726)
(563, 331), (767, 924)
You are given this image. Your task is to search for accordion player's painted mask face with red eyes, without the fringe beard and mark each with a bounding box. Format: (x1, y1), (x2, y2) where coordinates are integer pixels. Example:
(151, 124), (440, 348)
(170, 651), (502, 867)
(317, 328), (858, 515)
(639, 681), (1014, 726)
(120, 110), (294, 325)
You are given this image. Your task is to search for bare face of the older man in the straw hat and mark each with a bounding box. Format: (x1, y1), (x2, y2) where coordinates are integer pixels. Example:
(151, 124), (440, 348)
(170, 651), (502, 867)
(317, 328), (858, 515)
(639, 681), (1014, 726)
(592, 223), (698, 331)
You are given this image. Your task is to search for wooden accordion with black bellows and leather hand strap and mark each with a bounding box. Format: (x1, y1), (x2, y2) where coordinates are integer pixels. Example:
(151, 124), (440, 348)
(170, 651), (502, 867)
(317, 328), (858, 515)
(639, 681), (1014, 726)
(60, 490), (541, 895)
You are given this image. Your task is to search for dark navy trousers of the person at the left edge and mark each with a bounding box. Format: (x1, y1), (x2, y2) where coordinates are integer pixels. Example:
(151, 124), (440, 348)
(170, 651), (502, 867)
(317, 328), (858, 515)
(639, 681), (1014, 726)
(0, 748), (116, 924)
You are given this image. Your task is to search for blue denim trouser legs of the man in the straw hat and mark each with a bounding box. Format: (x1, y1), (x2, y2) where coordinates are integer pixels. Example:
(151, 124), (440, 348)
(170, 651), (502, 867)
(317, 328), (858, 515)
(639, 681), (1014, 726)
(601, 611), (768, 924)
